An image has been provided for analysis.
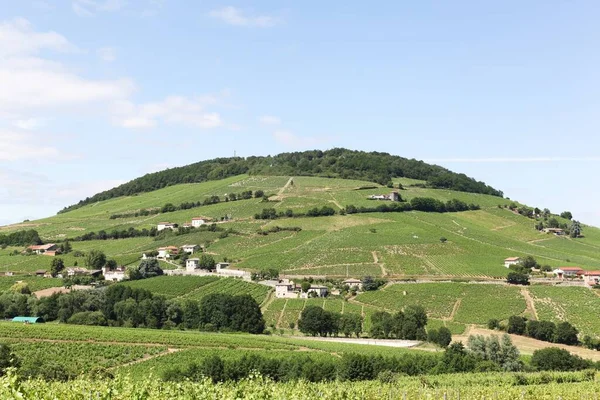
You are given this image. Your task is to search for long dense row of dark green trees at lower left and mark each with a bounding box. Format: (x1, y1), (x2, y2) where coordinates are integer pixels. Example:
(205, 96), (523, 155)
(0, 285), (265, 334)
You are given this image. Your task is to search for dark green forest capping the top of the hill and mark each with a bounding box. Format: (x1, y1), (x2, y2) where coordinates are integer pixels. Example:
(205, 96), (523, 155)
(60, 148), (503, 213)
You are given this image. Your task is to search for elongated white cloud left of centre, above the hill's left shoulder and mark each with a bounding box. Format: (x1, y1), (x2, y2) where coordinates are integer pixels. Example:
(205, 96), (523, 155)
(115, 96), (223, 129)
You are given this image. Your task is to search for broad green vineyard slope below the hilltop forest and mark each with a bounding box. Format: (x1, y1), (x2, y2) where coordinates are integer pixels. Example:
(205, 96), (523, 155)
(0, 175), (600, 278)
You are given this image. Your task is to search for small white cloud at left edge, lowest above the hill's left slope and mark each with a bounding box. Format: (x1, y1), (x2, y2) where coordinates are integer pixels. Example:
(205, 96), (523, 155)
(0, 131), (59, 161)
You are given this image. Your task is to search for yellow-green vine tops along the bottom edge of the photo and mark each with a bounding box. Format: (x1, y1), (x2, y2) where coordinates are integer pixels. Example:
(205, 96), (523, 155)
(0, 373), (600, 400)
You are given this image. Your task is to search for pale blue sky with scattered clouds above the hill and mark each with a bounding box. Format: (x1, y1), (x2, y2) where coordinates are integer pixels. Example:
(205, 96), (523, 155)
(0, 0), (600, 226)
